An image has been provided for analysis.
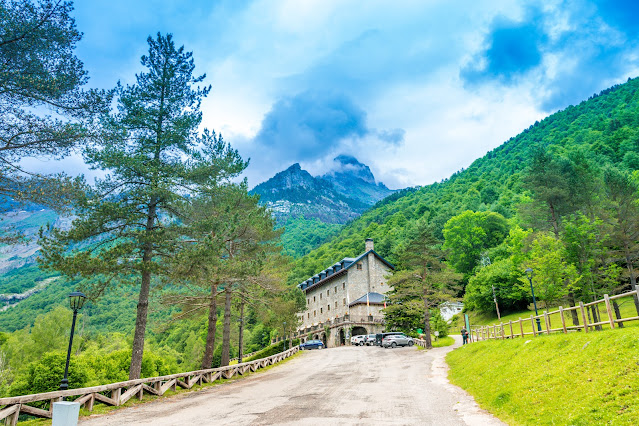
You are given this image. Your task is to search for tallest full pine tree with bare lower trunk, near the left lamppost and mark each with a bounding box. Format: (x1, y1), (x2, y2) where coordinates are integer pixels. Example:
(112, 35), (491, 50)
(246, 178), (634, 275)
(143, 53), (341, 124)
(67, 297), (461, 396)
(41, 34), (246, 379)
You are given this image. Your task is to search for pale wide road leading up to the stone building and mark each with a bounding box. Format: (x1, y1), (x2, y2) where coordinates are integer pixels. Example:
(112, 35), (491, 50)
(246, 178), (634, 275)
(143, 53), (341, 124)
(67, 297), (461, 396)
(80, 340), (503, 426)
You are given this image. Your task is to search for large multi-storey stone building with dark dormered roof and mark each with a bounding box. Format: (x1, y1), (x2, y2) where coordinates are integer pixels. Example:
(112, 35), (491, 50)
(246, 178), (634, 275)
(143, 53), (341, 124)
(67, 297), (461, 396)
(295, 238), (394, 347)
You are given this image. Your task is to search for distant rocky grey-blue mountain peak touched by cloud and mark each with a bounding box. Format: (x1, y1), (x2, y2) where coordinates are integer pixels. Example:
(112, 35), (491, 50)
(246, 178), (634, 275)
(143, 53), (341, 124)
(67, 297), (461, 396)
(251, 155), (393, 224)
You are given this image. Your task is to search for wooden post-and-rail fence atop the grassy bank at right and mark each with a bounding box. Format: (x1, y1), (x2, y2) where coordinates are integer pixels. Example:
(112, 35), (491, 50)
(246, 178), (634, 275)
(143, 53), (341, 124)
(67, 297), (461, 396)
(470, 286), (639, 342)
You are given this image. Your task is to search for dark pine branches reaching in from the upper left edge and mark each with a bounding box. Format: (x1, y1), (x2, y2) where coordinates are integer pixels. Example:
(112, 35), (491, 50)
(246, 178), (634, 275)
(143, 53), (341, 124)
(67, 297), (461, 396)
(0, 0), (109, 213)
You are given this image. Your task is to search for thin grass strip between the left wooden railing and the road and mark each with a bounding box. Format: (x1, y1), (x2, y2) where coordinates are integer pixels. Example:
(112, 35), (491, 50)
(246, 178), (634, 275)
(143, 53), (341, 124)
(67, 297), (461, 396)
(19, 352), (300, 426)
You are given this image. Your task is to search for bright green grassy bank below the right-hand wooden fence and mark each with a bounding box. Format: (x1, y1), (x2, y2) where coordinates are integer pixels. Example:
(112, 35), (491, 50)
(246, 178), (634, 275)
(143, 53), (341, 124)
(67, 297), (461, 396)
(446, 327), (639, 425)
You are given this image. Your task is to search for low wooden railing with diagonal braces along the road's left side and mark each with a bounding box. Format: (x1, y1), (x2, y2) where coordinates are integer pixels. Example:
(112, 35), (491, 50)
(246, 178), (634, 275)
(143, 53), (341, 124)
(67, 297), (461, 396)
(0, 346), (299, 426)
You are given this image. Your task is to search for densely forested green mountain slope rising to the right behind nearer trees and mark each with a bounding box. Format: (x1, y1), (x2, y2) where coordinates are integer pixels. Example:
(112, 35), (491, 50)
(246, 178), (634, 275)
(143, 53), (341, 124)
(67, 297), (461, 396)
(289, 79), (639, 284)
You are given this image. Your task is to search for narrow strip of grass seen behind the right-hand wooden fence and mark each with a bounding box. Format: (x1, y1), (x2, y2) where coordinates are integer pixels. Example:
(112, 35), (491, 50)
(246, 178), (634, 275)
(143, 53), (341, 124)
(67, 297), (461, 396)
(454, 296), (639, 336)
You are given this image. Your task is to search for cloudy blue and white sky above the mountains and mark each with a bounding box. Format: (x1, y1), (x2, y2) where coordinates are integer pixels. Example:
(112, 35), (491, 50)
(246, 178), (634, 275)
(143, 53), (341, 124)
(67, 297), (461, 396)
(45, 0), (639, 189)
